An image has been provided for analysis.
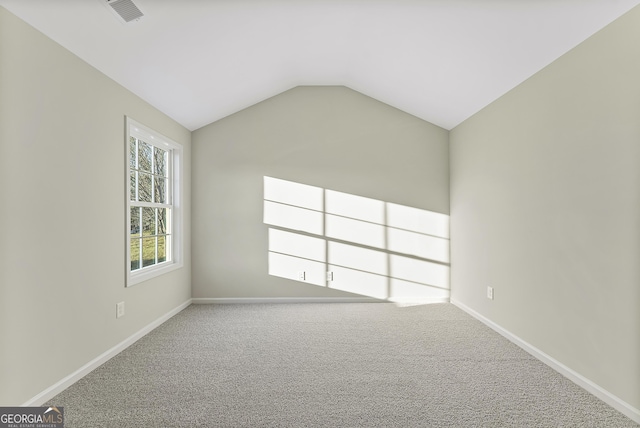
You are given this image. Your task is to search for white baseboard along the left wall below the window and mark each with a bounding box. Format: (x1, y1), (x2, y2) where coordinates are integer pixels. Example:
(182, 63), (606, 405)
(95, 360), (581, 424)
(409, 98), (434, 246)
(22, 299), (191, 407)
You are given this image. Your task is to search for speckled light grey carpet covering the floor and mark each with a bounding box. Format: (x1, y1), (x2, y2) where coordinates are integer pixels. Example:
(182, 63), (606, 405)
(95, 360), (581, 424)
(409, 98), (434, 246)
(48, 303), (640, 428)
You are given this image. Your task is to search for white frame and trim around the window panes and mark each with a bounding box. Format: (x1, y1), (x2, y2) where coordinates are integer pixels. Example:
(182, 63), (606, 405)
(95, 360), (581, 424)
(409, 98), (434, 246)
(125, 117), (184, 287)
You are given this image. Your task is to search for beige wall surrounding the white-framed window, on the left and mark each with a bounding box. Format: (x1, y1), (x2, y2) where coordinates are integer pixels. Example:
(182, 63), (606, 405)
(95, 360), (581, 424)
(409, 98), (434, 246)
(0, 7), (191, 405)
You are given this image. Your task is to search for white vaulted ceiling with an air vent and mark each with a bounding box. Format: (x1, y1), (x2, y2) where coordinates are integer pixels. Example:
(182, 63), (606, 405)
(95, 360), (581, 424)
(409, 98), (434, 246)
(0, 0), (640, 130)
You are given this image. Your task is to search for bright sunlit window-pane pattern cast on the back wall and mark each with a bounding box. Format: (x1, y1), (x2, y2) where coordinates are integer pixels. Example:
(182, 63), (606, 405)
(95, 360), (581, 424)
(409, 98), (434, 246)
(264, 176), (450, 303)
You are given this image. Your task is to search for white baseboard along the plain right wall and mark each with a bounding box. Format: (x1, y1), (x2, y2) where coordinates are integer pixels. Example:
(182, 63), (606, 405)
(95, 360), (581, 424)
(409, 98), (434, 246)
(451, 299), (640, 423)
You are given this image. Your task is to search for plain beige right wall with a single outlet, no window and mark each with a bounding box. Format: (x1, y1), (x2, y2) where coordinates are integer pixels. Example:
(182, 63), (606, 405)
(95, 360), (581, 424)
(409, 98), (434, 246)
(451, 4), (640, 409)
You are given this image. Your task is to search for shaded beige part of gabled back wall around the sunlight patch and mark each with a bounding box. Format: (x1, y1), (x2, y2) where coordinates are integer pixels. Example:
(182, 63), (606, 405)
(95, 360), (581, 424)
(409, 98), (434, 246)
(192, 87), (449, 298)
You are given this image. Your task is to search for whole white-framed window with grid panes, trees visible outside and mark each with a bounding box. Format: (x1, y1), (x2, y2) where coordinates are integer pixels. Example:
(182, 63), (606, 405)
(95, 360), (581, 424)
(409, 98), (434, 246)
(127, 118), (182, 286)
